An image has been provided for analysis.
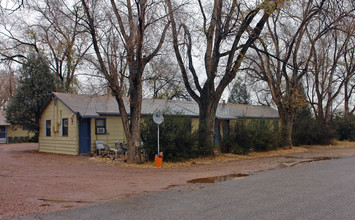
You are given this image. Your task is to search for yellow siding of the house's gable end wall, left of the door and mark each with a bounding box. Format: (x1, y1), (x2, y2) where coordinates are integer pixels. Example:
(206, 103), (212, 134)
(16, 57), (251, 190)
(38, 97), (79, 155)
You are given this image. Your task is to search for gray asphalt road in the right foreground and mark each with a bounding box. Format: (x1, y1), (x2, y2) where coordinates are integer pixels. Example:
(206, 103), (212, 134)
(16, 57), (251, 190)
(16, 157), (355, 220)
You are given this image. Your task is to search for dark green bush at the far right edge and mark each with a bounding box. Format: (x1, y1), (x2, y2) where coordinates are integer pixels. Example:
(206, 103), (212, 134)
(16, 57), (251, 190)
(332, 115), (355, 141)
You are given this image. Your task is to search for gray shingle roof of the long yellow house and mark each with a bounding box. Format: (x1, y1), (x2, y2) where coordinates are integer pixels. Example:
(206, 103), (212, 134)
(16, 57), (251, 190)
(53, 92), (279, 119)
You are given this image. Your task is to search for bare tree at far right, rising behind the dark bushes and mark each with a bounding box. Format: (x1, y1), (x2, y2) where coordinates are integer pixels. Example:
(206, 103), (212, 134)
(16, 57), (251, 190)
(307, 18), (354, 125)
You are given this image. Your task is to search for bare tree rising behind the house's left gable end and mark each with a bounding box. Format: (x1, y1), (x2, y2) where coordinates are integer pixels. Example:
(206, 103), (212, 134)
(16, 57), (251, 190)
(0, 0), (91, 92)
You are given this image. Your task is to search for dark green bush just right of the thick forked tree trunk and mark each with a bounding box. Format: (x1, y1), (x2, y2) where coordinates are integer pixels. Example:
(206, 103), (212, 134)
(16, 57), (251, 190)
(221, 119), (281, 154)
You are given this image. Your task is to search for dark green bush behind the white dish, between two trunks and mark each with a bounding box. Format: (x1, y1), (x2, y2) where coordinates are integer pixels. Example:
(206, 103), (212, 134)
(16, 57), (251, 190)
(141, 116), (199, 161)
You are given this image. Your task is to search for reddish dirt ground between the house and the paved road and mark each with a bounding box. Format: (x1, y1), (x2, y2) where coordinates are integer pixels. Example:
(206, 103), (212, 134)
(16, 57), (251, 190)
(0, 142), (355, 219)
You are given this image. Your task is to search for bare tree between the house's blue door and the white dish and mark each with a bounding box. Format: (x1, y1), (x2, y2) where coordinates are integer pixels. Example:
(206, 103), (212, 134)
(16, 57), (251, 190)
(81, 0), (169, 163)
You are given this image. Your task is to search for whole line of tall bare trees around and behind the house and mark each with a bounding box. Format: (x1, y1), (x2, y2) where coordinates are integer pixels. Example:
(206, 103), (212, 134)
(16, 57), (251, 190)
(0, 0), (355, 162)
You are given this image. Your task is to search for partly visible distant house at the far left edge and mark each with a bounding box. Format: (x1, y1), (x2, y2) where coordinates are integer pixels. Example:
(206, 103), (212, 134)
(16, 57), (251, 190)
(0, 111), (34, 144)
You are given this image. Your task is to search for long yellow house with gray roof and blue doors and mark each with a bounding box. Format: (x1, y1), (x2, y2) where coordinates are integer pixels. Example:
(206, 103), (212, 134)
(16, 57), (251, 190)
(39, 92), (279, 155)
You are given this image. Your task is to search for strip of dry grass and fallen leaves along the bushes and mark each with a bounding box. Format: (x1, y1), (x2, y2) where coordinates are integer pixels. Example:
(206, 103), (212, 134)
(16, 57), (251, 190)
(90, 141), (355, 169)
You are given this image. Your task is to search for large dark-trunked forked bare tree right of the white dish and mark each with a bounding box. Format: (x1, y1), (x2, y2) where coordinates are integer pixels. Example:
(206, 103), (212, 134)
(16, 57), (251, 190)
(166, 0), (283, 154)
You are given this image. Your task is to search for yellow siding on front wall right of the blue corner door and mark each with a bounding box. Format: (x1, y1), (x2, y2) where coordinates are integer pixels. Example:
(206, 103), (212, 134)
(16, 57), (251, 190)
(91, 116), (126, 152)
